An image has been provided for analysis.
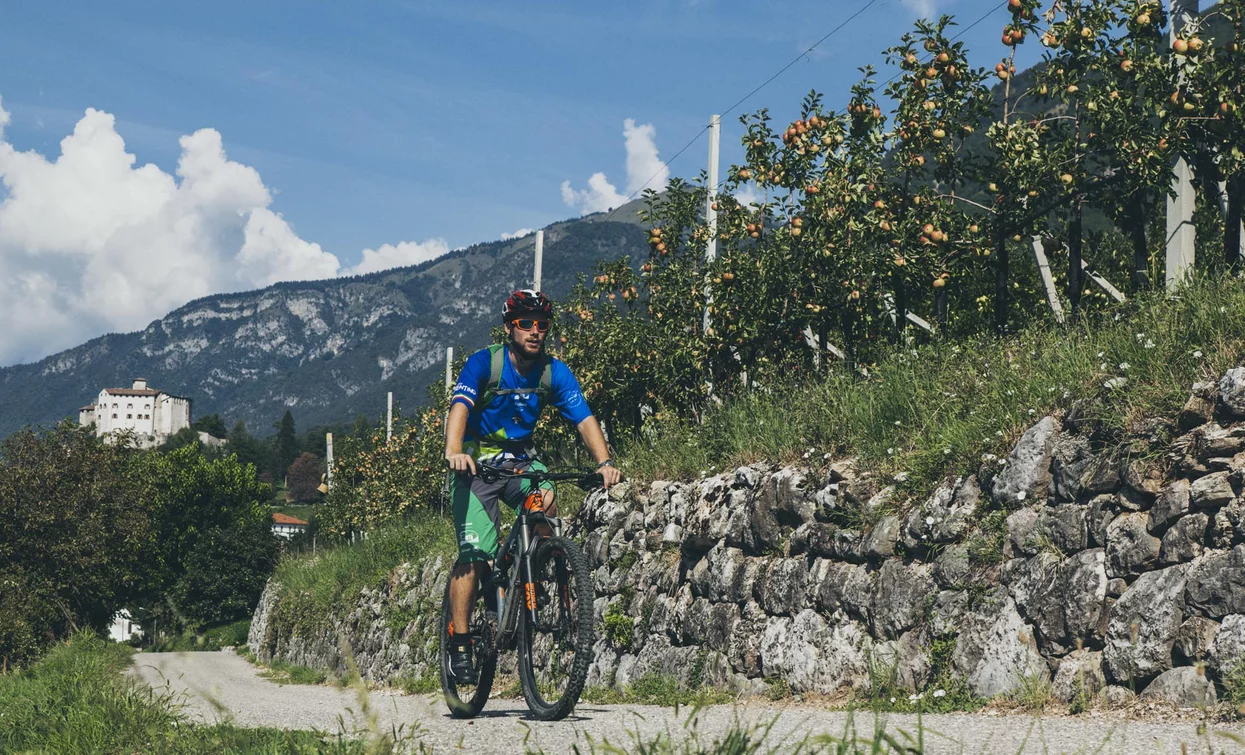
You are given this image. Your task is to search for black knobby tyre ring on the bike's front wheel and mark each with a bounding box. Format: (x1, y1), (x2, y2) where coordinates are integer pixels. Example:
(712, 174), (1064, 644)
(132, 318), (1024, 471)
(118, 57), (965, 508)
(519, 537), (594, 721)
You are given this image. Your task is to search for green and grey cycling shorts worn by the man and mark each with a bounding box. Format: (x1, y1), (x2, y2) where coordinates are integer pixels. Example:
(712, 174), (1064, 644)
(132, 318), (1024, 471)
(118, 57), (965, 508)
(449, 461), (553, 563)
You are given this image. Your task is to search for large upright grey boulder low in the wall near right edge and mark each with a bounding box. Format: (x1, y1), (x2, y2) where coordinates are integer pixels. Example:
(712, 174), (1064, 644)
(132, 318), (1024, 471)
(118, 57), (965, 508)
(1103, 564), (1189, 681)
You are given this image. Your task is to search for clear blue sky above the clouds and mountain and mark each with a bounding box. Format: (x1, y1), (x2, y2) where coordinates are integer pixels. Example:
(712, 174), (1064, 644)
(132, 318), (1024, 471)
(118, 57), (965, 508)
(0, 0), (1037, 364)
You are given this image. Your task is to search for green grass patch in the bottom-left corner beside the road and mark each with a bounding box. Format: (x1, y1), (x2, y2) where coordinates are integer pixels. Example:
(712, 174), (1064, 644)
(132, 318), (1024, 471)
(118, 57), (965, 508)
(0, 632), (416, 755)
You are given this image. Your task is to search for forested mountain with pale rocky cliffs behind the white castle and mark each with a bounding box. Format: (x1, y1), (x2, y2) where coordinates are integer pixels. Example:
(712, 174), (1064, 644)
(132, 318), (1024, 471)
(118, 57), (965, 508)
(0, 202), (647, 437)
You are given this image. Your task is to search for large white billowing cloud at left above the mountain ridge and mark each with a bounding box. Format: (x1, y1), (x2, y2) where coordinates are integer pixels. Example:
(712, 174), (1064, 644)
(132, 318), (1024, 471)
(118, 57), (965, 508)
(0, 95), (448, 365)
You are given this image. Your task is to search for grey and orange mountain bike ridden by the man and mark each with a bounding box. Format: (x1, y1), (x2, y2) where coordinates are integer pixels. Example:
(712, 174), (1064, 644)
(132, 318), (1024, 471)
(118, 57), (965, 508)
(439, 463), (601, 721)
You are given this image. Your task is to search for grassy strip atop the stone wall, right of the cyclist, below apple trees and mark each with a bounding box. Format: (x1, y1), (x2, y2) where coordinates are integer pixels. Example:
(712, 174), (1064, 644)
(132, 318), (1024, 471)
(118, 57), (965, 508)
(621, 278), (1245, 490)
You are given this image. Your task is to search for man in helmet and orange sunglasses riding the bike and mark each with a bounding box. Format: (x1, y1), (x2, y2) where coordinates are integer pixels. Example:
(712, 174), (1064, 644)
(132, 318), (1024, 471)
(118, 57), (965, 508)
(446, 289), (621, 684)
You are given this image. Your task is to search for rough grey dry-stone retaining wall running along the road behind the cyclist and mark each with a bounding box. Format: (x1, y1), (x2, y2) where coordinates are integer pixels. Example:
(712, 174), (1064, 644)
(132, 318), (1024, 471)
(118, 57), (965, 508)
(250, 368), (1245, 705)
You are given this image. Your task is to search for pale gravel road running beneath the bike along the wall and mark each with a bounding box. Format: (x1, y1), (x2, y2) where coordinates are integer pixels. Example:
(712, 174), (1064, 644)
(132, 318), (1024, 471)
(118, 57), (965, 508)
(132, 652), (1245, 755)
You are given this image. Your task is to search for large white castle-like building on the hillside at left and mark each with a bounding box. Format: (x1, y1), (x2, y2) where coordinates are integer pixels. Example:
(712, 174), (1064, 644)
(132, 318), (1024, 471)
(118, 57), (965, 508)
(78, 378), (190, 446)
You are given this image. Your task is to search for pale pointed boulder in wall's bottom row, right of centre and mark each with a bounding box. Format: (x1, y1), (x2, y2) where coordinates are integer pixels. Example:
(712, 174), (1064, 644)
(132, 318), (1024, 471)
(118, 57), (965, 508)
(951, 594), (1050, 698)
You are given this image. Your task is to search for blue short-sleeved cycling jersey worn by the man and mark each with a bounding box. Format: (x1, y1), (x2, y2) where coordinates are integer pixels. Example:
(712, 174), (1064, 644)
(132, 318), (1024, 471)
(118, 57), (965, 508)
(449, 346), (593, 461)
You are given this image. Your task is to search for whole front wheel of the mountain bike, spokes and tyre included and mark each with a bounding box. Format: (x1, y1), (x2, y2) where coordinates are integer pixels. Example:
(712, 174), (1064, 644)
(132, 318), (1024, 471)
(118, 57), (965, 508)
(519, 537), (594, 721)
